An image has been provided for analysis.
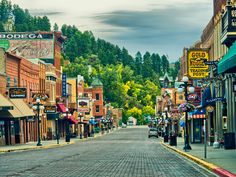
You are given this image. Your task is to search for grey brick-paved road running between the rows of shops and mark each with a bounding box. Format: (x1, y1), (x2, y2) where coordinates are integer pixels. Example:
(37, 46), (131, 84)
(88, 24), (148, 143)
(0, 127), (218, 177)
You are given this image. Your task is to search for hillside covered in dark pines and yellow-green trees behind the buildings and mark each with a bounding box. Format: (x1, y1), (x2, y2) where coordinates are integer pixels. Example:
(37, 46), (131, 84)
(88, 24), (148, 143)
(0, 0), (179, 123)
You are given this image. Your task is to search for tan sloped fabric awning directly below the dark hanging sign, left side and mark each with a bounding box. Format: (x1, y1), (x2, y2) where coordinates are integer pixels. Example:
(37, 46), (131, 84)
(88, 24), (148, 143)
(9, 99), (35, 117)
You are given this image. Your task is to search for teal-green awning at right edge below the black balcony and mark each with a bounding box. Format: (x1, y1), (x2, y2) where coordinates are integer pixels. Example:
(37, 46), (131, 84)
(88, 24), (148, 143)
(218, 42), (236, 74)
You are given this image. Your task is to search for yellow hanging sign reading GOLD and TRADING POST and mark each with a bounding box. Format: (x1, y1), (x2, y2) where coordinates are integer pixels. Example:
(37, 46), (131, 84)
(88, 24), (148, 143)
(187, 49), (209, 79)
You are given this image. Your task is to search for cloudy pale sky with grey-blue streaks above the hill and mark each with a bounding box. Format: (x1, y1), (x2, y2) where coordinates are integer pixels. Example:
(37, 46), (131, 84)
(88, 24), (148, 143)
(11, 0), (213, 61)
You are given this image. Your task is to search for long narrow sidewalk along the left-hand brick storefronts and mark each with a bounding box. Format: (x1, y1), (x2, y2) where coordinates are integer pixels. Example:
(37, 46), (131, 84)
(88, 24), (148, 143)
(0, 129), (118, 153)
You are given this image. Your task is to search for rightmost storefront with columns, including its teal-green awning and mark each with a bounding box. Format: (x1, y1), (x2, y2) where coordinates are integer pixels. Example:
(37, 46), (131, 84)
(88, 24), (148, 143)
(216, 42), (236, 141)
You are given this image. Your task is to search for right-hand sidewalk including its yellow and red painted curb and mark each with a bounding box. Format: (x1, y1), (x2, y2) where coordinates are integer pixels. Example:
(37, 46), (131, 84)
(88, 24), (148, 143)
(162, 137), (236, 177)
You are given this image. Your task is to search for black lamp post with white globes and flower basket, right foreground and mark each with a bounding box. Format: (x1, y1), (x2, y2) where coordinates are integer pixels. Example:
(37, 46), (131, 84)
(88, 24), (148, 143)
(178, 76), (194, 151)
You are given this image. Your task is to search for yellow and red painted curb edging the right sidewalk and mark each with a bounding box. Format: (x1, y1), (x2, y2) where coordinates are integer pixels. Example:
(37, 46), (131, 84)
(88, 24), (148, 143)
(161, 142), (236, 177)
